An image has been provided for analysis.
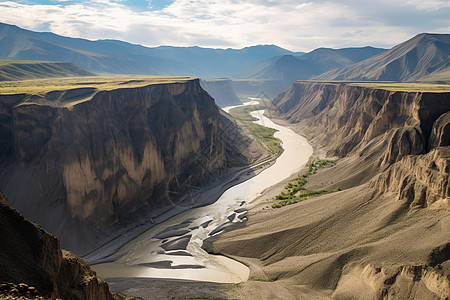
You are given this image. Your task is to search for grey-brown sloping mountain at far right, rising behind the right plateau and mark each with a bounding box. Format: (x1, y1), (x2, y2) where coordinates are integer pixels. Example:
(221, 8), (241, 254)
(316, 33), (450, 82)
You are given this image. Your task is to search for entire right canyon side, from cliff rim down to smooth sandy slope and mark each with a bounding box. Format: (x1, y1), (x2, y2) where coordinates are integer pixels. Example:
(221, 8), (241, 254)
(205, 82), (450, 299)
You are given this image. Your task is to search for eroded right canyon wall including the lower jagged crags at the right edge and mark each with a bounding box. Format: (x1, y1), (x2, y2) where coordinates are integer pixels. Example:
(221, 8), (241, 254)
(268, 81), (450, 207)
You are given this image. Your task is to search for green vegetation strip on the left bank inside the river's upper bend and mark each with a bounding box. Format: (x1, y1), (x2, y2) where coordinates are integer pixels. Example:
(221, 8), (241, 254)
(230, 100), (283, 156)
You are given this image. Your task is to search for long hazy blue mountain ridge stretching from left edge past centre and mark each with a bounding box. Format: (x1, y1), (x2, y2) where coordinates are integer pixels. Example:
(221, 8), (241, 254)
(0, 23), (294, 77)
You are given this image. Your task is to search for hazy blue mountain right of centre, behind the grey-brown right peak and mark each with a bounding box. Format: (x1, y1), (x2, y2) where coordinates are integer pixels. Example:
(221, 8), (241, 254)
(237, 47), (385, 85)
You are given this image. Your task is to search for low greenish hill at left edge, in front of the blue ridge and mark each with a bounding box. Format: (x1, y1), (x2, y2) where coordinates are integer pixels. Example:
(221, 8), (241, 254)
(0, 59), (94, 81)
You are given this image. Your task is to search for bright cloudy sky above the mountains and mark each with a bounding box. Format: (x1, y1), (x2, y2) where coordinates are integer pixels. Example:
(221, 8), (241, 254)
(0, 0), (450, 52)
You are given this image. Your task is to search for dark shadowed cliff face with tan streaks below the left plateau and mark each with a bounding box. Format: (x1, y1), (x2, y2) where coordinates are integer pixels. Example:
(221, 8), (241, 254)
(0, 80), (226, 253)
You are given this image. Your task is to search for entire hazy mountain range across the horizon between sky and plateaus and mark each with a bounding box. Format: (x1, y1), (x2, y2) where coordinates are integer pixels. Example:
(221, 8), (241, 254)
(0, 23), (450, 88)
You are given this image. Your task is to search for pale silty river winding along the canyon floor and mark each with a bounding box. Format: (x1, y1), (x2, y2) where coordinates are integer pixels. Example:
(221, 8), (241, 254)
(93, 102), (313, 283)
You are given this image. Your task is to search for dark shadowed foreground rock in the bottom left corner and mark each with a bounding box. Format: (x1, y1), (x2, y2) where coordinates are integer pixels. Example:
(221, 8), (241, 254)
(0, 192), (119, 300)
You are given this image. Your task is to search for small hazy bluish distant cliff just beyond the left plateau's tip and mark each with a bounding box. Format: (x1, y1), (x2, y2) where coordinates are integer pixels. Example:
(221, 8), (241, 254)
(200, 79), (242, 107)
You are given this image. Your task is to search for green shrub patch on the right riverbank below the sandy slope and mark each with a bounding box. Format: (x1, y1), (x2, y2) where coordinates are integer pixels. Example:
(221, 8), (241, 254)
(272, 159), (340, 208)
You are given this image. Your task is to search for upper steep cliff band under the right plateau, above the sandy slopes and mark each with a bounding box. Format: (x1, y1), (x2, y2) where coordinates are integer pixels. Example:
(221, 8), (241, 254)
(268, 81), (450, 163)
